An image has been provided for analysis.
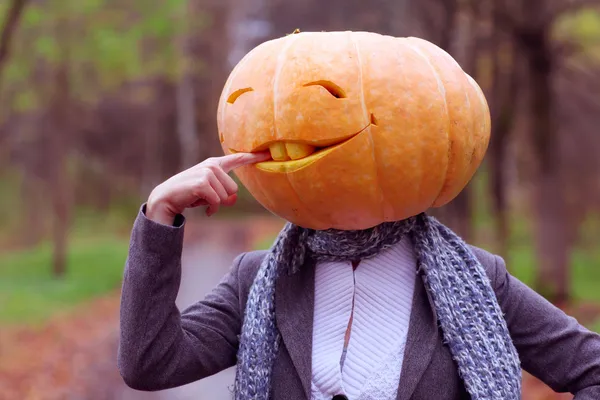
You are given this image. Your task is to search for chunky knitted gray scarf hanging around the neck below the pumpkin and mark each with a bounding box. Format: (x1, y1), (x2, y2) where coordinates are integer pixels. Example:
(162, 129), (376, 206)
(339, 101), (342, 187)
(234, 214), (521, 400)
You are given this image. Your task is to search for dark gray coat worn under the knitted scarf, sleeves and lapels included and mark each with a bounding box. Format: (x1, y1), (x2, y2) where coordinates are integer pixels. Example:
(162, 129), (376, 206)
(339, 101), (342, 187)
(118, 208), (600, 400)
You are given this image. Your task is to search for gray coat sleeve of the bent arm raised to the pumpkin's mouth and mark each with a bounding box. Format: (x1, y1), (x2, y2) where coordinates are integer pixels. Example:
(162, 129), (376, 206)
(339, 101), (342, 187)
(118, 206), (244, 391)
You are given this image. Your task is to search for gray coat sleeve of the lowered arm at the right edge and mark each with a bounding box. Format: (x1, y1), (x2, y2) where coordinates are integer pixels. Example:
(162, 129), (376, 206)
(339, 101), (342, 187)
(493, 256), (600, 400)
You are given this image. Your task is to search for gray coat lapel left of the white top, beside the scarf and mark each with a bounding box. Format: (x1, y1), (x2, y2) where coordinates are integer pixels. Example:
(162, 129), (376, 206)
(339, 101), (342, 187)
(275, 262), (315, 399)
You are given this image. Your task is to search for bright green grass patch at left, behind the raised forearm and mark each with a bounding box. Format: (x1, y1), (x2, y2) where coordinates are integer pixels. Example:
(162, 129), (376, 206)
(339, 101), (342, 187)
(0, 236), (128, 324)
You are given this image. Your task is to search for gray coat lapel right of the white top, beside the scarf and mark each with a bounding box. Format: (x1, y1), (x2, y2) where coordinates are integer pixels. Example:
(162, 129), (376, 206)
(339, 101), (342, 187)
(397, 274), (439, 400)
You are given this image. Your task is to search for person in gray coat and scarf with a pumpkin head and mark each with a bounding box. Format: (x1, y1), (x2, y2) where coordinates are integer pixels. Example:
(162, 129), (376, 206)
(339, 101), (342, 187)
(118, 32), (600, 400)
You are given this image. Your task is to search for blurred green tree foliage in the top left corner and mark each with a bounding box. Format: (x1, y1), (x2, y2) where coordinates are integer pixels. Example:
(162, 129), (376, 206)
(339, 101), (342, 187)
(0, 0), (206, 111)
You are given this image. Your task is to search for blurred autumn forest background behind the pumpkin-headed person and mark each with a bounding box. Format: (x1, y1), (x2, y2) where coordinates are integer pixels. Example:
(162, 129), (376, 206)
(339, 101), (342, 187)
(0, 0), (600, 400)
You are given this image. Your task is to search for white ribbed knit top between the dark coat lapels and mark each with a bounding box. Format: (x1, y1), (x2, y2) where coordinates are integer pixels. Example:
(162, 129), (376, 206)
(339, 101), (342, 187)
(311, 239), (417, 400)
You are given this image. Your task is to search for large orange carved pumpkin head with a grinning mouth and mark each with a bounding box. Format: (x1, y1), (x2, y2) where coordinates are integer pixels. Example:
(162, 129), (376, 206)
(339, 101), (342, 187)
(217, 32), (490, 230)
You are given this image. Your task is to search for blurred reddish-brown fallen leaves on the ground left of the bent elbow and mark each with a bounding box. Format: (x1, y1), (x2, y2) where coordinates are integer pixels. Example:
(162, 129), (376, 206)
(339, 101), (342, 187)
(0, 293), (119, 400)
